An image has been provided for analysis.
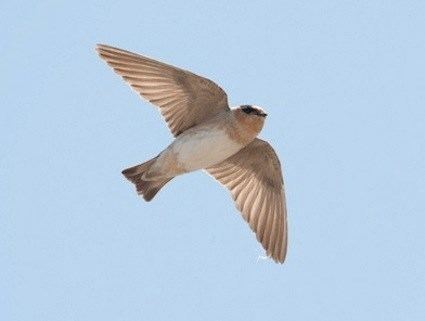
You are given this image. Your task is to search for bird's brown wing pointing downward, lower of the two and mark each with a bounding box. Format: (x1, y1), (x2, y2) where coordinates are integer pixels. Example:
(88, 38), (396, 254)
(206, 138), (288, 263)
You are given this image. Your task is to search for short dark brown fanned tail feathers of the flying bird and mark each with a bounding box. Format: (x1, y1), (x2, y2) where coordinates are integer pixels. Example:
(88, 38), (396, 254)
(122, 157), (172, 202)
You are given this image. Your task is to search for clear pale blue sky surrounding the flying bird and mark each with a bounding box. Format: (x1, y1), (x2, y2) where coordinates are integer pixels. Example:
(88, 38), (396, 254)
(0, 1), (425, 321)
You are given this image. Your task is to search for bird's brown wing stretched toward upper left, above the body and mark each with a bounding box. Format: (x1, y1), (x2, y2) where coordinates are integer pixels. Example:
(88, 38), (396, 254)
(96, 45), (229, 136)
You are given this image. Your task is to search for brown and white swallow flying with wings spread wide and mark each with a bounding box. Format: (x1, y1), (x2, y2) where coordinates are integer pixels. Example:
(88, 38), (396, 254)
(96, 44), (288, 263)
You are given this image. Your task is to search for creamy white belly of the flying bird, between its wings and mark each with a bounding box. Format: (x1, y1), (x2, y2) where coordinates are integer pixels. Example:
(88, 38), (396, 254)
(172, 129), (243, 171)
